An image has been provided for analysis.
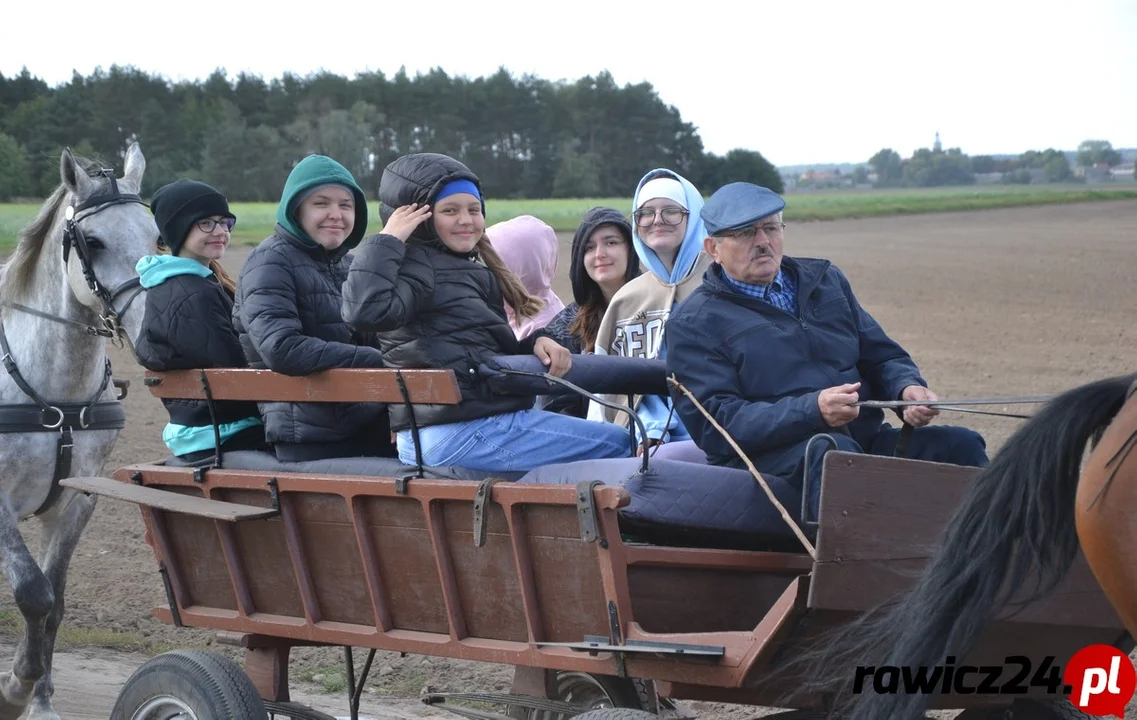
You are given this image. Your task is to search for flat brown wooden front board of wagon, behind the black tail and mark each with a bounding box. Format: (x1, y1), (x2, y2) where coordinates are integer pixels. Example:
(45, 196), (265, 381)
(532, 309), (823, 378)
(808, 452), (1122, 628)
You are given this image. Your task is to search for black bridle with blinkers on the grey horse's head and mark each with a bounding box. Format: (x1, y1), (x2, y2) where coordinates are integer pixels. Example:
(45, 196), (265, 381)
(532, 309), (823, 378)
(57, 168), (149, 349)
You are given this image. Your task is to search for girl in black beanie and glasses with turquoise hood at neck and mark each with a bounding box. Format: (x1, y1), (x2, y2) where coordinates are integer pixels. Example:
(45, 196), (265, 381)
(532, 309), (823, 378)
(135, 180), (265, 462)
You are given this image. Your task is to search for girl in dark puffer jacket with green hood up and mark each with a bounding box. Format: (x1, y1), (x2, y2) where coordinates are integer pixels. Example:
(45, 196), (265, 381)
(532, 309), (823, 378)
(233, 155), (396, 462)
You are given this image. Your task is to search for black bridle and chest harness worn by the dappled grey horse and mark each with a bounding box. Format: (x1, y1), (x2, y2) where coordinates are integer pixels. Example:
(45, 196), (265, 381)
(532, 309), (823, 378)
(0, 168), (149, 516)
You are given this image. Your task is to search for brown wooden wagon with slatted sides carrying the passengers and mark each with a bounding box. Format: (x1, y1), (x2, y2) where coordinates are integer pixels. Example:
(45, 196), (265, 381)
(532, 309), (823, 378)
(75, 370), (1132, 720)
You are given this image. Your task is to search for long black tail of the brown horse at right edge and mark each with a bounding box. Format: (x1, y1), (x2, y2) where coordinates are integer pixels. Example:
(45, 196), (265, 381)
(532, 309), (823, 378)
(794, 375), (1137, 720)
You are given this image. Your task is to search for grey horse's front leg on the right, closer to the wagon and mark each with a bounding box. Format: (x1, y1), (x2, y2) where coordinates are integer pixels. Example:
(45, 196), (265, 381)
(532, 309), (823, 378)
(27, 493), (97, 720)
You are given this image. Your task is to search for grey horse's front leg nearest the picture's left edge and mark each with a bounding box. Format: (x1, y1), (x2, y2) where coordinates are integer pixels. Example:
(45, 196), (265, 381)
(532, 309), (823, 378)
(0, 498), (56, 720)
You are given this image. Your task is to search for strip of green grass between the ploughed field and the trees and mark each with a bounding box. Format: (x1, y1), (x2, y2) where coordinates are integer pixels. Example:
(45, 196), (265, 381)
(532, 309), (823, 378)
(0, 183), (1137, 251)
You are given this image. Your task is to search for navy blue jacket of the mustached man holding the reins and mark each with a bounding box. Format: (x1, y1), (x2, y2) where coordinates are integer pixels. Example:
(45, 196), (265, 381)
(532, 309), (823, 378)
(664, 257), (927, 465)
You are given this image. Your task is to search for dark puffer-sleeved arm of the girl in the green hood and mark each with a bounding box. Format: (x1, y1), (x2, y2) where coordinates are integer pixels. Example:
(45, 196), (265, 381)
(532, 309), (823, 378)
(241, 253), (383, 375)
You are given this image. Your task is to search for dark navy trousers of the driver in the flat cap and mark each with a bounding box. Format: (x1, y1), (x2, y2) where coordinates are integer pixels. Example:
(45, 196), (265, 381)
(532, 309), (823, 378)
(750, 424), (988, 520)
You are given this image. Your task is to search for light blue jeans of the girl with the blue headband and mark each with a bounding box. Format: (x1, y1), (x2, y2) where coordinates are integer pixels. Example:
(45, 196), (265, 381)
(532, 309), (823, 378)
(397, 409), (633, 472)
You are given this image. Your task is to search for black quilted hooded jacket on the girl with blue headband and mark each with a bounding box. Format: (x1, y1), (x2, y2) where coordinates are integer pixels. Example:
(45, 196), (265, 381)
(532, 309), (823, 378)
(343, 154), (545, 430)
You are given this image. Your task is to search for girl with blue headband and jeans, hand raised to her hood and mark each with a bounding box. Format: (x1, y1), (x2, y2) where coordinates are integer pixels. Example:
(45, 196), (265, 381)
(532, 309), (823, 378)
(343, 154), (632, 472)
